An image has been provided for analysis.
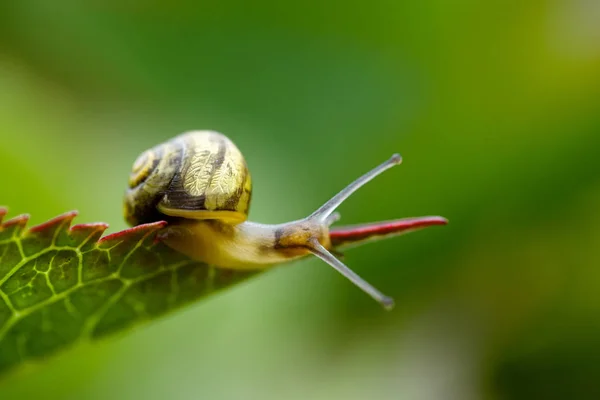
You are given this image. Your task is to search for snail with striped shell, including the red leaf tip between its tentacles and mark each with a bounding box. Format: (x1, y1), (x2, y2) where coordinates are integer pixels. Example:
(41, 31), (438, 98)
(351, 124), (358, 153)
(124, 131), (447, 309)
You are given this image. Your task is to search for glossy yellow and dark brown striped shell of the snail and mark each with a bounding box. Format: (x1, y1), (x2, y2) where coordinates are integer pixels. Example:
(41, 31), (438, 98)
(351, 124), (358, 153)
(124, 131), (252, 225)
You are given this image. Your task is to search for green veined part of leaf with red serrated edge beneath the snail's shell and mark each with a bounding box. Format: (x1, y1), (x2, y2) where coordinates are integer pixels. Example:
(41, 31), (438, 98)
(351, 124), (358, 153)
(0, 208), (255, 375)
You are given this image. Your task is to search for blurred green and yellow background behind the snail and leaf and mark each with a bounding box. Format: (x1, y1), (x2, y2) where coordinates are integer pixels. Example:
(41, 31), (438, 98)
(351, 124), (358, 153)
(0, 0), (600, 400)
